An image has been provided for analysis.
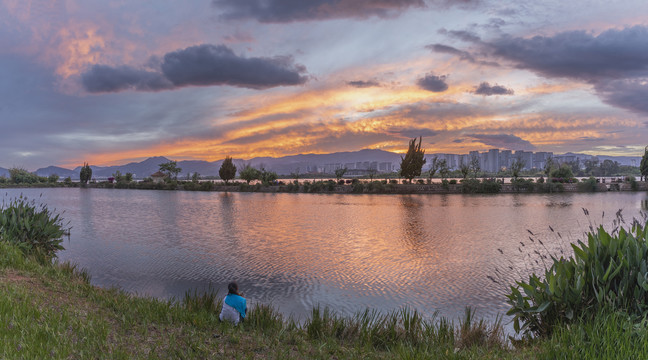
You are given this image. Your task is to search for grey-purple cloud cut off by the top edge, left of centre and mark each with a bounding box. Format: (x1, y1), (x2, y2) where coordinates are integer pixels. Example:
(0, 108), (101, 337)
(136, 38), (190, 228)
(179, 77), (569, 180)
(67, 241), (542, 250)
(212, 0), (425, 23)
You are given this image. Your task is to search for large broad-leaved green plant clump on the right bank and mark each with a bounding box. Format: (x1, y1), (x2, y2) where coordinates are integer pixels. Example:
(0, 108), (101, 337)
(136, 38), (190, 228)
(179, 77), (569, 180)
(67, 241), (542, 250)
(506, 217), (648, 336)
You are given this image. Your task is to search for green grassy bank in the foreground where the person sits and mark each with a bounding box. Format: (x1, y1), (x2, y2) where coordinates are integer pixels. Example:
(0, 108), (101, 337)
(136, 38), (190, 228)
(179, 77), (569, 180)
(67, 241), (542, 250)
(0, 241), (648, 359)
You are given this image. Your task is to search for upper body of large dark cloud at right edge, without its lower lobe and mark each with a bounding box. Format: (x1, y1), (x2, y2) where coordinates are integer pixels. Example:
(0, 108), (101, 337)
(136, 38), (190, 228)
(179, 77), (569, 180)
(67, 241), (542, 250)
(487, 26), (648, 81)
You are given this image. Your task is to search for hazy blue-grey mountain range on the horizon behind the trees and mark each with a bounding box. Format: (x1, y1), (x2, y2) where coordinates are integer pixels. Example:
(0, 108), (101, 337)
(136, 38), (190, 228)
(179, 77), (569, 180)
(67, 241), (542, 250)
(0, 149), (641, 179)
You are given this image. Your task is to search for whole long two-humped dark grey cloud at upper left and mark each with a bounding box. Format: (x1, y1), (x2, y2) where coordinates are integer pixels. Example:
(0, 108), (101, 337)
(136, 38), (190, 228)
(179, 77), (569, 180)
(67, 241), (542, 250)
(81, 44), (307, 93)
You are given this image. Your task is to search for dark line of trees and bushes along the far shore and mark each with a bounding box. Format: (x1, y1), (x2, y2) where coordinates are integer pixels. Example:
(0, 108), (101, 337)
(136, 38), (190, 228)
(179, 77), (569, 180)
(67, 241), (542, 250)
(0, 138), (648, 194)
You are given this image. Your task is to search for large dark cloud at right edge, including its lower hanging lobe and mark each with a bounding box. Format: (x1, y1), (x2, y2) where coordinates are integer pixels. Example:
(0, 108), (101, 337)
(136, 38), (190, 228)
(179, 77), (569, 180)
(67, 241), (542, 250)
(484, 26), (648, 114)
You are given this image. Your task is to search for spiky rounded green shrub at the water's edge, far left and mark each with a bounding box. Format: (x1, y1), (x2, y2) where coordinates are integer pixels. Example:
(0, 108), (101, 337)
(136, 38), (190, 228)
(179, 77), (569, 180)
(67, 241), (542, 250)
(0, 196), (69, 258)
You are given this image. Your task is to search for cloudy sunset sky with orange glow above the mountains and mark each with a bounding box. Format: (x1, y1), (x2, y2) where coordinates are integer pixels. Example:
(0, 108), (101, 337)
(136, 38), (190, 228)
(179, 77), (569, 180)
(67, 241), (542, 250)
(0, 0), (648, 170)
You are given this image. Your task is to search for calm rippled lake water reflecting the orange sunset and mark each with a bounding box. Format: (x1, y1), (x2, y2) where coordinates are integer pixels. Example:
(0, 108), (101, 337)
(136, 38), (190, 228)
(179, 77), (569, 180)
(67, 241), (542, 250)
(2, 189), (648, 324)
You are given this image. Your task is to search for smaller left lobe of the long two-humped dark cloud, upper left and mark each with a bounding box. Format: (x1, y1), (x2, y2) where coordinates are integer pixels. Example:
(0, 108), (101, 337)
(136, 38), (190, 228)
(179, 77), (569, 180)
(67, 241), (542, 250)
(81, 65), (173, 93)
